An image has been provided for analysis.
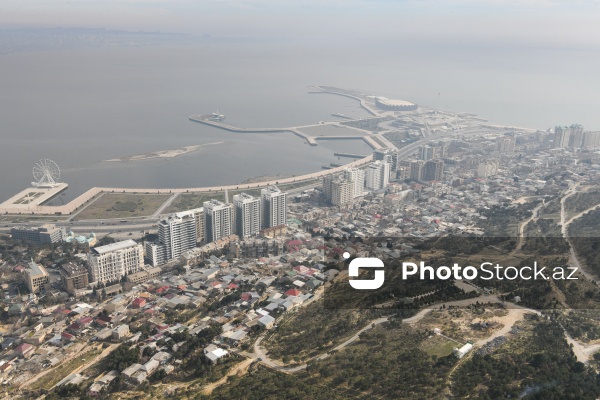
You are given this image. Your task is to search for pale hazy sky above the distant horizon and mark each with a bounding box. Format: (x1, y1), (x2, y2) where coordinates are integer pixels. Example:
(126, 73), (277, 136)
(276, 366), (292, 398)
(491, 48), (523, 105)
(0, 0), (600, 47)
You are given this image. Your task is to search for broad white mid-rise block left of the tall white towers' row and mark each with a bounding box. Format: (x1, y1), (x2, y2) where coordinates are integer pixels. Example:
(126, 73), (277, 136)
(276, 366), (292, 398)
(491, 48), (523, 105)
(88, 239), (144, 283)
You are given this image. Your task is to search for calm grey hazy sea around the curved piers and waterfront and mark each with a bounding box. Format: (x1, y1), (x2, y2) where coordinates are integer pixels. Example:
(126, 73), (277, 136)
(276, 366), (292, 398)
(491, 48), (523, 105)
(0, 36), (600, 204)
